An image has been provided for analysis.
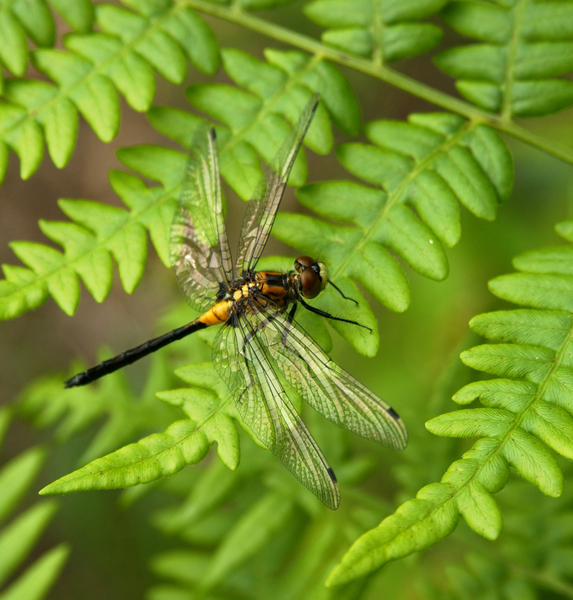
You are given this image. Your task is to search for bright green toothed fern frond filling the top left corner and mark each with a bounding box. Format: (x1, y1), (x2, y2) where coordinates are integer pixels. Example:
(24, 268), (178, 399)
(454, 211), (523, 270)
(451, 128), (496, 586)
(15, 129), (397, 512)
(0, 2), (218, 182)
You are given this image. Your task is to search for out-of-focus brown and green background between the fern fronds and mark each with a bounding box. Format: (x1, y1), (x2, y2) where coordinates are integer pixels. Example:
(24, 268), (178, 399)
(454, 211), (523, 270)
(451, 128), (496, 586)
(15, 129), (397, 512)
(0, 3), (573, 599)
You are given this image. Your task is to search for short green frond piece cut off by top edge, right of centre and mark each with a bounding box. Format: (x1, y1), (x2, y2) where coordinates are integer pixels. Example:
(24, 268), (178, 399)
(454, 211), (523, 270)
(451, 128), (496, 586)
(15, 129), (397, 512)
(303, 0), (445, 64)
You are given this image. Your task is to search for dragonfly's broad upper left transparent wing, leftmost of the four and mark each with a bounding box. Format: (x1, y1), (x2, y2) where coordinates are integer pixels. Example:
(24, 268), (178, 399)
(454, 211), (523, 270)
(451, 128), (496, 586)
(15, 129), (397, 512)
(170, 127), (233, 311)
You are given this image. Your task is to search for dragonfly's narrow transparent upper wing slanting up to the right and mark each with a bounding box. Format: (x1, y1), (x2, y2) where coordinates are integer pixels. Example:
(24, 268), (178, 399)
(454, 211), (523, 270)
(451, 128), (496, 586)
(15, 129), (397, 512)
(236, 94), (319, 275)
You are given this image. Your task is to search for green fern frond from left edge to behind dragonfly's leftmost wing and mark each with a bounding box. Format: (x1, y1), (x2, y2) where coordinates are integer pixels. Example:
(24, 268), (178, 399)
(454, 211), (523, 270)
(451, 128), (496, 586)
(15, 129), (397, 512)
(0, 157), (179, 319)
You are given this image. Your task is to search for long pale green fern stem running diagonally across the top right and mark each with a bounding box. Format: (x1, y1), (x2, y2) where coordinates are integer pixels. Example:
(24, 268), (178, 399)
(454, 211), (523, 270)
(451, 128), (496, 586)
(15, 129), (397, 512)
(183, 0), (573, 165)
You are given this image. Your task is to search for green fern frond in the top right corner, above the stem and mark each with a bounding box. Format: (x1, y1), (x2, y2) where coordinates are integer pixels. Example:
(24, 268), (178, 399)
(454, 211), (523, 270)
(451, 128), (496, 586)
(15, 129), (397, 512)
(435, 0), (573, 119)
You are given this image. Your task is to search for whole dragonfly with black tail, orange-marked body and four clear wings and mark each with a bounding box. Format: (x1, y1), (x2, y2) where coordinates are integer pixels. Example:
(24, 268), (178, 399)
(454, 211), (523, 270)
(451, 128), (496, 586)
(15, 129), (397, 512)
(65, 95), (408, 510)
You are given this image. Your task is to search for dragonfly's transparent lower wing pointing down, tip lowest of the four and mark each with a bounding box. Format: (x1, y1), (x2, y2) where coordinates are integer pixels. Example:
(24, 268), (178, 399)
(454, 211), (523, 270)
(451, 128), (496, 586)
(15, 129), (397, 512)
(213, 315), (340, 510)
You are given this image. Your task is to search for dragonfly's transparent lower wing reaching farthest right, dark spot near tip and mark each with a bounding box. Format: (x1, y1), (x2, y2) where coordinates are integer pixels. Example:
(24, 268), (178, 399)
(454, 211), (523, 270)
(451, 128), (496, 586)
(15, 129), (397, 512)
(250, 304), (408, 450)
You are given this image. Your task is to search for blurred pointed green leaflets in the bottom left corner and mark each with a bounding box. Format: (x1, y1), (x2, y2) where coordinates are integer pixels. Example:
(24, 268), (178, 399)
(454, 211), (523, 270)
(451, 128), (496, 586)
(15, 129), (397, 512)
(0, 408), (69, 600)
